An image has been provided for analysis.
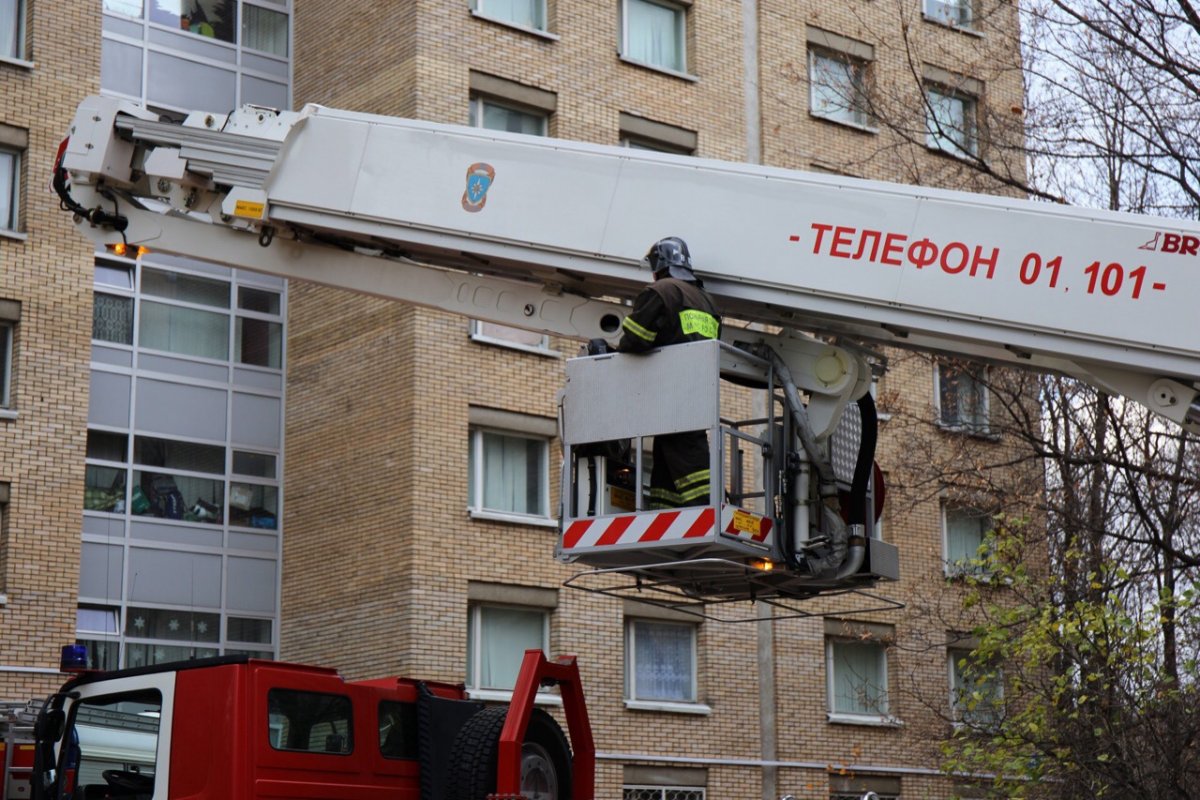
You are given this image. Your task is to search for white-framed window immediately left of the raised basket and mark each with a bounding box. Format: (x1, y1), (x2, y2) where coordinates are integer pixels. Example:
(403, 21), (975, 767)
(467, 428), (550, 518)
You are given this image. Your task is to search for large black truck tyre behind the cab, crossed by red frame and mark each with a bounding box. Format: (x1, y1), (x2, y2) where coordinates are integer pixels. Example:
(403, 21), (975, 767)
(446, 706), (571, 800)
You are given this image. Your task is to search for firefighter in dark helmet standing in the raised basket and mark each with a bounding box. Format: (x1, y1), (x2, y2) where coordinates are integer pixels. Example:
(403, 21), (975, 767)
(617, 236), (721, 509)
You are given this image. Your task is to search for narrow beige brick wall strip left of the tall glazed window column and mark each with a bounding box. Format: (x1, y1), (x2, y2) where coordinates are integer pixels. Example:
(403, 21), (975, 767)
(0, 0), (100, 698)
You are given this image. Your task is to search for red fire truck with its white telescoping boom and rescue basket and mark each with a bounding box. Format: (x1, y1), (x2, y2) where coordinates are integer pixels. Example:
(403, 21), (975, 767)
(34, 97), (1200, 800)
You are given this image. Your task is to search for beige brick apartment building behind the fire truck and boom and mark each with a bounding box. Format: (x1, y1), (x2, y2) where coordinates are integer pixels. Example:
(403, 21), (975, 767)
(0, 0), (1021, 800)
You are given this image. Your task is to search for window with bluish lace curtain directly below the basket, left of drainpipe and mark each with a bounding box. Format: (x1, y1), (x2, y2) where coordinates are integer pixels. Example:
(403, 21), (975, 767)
(625, 619), (696, 703)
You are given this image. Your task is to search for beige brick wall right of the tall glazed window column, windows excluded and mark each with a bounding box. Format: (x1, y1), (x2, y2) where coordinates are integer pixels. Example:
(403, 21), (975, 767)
(282, 0), (1020, 800)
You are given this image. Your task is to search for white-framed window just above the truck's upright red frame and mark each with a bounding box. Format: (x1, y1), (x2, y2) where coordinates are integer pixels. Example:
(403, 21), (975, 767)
(467, 603), (550, 691)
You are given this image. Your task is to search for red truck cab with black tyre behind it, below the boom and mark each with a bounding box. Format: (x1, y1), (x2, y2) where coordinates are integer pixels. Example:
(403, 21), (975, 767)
(32, 650), (593, 800)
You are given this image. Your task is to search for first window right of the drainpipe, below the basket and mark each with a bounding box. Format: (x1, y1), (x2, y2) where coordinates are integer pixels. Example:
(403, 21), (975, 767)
(826, 619), (892, 724)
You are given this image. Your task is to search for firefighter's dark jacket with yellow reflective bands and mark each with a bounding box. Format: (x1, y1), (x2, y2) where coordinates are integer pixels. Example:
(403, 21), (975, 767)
(617, 277), (721, 353)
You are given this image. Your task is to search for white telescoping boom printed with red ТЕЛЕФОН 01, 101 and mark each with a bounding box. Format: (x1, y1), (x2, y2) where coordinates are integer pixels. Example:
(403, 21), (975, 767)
(56, 97), (1200, 614)
